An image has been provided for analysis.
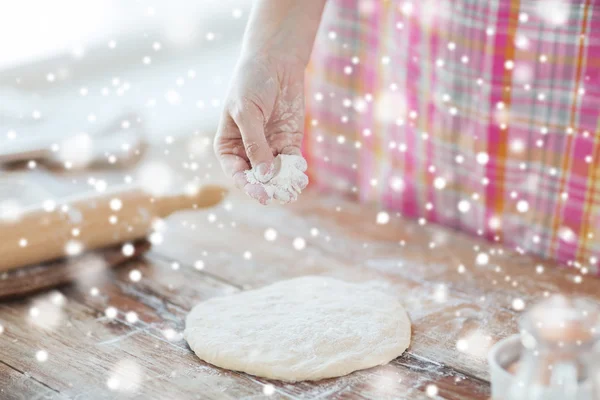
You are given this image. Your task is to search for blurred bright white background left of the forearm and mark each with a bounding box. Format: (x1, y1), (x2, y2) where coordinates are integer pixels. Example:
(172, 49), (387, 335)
(0, 0), (251, 158)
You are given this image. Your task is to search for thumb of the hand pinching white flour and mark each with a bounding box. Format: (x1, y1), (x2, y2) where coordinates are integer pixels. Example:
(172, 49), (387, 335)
(231, 102), (274, 183)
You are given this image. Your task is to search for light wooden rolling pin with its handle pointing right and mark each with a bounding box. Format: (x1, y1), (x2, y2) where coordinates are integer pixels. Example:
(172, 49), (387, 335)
(0, 186), (226, 272)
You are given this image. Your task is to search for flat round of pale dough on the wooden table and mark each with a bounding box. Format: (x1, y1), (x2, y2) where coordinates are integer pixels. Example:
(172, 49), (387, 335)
(184, 276), (411, 382)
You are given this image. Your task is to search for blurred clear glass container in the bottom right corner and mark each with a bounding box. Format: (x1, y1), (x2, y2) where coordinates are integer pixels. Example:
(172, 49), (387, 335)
(507, 295), (600, 400)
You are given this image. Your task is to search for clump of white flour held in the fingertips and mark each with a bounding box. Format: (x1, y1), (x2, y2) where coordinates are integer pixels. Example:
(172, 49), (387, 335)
(246, 154), (308, 204)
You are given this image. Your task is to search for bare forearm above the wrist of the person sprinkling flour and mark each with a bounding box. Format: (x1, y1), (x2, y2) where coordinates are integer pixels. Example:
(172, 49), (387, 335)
(242, 0), (326, 65)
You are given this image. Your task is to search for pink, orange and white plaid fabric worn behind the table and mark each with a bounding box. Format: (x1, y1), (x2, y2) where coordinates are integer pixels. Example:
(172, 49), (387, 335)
(305, 0), (600, 274)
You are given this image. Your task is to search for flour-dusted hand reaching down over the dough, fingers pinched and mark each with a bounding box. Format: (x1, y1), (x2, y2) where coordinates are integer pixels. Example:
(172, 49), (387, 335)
(214, 56), (308, 204)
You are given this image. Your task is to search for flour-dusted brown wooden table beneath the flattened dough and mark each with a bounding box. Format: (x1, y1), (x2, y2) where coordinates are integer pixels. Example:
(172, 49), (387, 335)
(0, 139), (600, 399)
